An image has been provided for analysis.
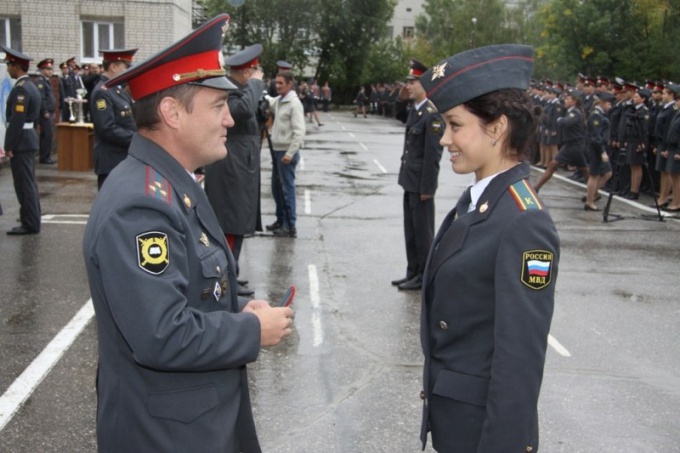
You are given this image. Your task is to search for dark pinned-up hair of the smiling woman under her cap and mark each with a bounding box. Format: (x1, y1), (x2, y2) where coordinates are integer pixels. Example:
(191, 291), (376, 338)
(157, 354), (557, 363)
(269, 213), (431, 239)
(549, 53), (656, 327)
(463, 88), (541, 160)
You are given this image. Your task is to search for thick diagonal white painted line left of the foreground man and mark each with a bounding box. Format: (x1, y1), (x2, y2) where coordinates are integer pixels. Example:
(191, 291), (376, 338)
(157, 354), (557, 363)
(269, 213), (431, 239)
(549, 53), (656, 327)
(0, 299), (94, 431)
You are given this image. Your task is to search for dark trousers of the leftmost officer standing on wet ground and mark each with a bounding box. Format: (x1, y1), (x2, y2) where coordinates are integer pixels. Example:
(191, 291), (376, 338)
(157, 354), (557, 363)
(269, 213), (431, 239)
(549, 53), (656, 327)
(9, 150), (40, 232)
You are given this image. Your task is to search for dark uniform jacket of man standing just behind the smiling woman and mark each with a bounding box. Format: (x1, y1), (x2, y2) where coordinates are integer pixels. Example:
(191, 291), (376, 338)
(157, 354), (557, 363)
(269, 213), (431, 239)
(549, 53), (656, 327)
(398, 100), (444, 195)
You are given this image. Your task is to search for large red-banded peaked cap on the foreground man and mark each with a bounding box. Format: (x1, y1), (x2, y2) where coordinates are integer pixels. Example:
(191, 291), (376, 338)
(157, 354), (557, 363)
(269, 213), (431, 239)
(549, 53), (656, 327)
(105, 14), (236, 99)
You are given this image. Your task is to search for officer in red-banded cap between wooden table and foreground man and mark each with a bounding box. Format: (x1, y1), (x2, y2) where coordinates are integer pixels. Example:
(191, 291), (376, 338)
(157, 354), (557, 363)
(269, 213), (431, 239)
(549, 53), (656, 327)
(90, 49), (137, 189)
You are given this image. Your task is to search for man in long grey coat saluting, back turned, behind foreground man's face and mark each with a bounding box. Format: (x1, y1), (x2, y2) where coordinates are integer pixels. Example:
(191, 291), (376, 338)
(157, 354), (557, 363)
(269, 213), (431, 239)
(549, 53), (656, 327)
(205, 44), (265, 296)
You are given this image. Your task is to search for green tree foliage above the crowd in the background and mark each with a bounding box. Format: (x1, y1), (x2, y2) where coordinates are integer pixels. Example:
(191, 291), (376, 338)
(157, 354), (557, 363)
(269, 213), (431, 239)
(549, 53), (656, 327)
(199, 0), (680, 101)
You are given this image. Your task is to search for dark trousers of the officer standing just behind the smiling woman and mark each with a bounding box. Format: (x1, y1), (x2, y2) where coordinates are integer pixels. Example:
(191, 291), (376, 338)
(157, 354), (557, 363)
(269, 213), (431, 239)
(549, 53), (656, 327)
(404, 192), (434, 278)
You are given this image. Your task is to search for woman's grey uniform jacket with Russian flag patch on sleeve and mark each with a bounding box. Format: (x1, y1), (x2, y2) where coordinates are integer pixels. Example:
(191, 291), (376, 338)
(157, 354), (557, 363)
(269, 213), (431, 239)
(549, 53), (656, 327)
(421, 164), (559, 453)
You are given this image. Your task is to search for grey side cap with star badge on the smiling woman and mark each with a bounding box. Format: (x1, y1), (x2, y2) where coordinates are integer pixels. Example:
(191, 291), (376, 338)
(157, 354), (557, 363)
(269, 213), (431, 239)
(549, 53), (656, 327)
(420, 44), (534, 112)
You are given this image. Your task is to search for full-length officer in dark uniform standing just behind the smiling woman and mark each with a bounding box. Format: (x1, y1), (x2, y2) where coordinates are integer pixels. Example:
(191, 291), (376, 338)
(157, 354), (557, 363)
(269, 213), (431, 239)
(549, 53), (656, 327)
(392, 60), (444, 289)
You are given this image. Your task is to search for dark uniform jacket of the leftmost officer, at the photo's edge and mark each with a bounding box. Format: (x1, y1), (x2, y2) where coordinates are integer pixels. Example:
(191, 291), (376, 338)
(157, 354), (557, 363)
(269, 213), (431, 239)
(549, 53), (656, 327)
(5, 76), (41, 153)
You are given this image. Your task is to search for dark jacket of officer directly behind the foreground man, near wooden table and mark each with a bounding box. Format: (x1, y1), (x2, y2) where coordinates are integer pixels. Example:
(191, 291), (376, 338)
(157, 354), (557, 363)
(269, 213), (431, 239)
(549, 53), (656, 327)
(90, 76), (137, 175)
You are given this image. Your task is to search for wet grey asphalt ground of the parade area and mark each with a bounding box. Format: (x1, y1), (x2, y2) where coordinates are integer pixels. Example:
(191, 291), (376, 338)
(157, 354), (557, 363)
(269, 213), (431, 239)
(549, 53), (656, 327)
(0, 112), (680, 453)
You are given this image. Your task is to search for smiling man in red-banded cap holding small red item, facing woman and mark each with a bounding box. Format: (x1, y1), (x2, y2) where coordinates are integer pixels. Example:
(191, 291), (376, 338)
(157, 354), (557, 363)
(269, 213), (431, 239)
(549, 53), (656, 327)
(83, 14), (293, 453)
